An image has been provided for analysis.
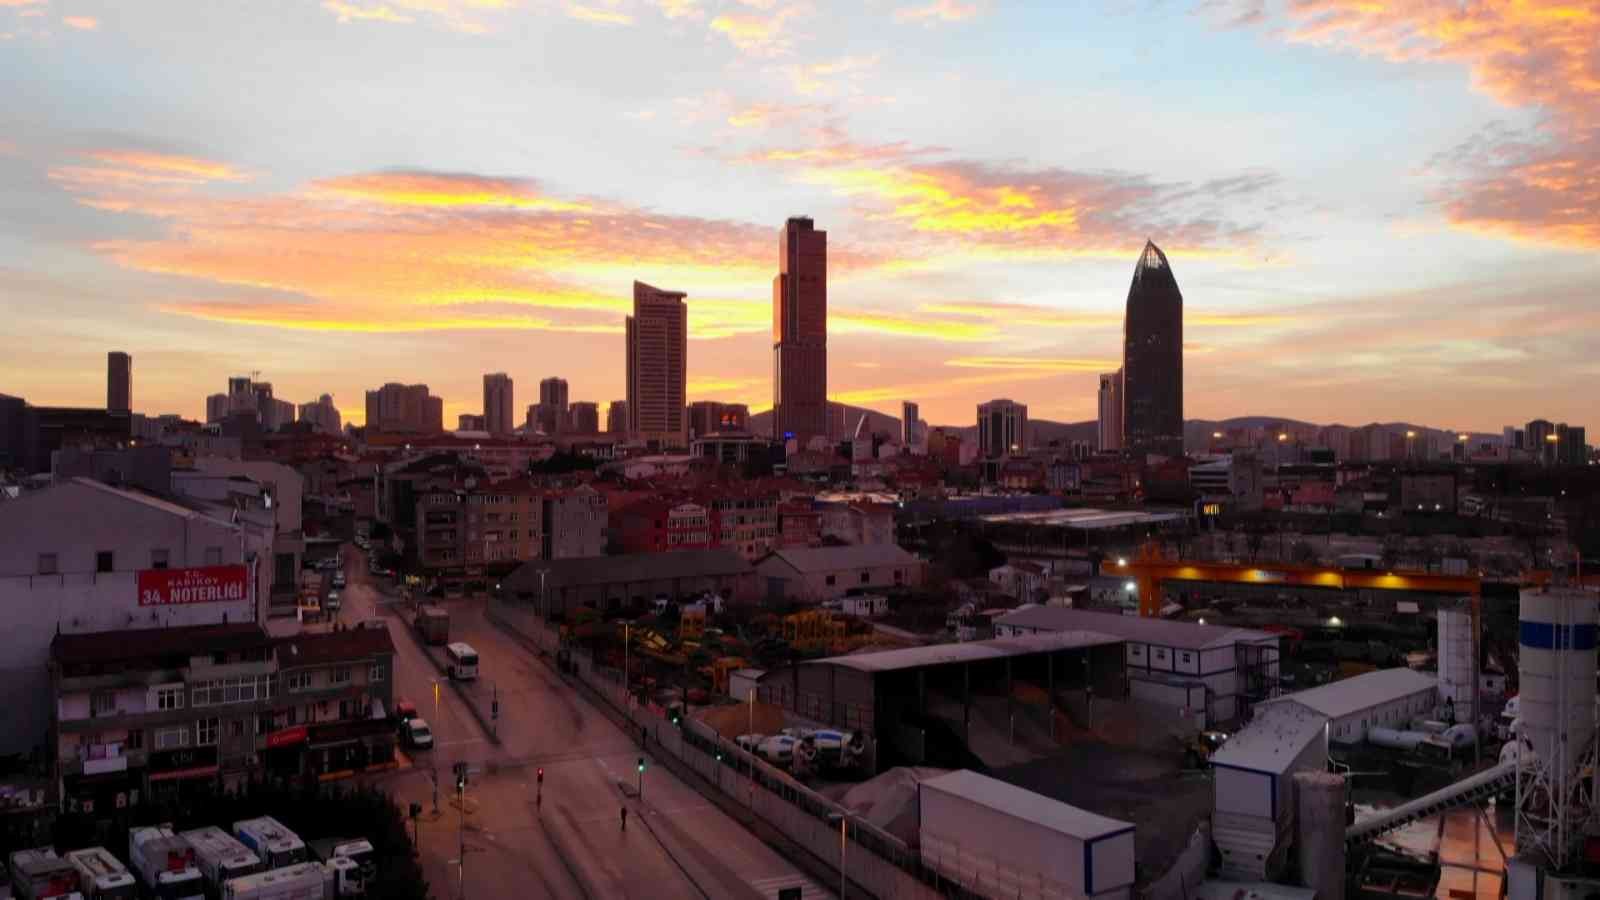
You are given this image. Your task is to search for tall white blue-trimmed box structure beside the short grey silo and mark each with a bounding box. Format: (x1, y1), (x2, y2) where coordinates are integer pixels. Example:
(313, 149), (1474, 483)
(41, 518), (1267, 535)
(1211, 703), (1328, 881)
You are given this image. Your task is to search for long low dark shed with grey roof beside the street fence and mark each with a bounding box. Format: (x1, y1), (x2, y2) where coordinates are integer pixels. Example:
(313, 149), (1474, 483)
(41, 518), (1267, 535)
(501, 549), (757, 615)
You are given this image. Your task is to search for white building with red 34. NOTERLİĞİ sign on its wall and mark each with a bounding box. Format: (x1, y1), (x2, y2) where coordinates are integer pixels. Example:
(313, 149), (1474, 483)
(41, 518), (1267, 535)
(0, 477), (262, 754)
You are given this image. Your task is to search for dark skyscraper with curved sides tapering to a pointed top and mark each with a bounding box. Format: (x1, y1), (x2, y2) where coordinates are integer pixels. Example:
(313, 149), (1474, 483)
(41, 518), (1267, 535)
(1122, 242), (1184, 458)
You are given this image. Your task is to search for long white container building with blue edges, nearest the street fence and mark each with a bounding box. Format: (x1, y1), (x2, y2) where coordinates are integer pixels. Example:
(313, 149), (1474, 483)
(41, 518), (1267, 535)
(917, 769), (1134, 900)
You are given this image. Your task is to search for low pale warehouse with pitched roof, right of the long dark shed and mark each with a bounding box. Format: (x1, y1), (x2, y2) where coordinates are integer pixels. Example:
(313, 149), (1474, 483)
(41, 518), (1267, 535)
(755, 543), (926, 604)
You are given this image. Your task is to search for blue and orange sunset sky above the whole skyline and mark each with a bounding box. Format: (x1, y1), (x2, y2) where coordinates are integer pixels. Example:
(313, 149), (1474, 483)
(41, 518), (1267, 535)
(0, 0), (1600, 431)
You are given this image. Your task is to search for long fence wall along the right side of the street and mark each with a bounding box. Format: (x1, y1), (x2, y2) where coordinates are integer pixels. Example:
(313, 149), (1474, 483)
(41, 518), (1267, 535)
(488, 599), (978, 900)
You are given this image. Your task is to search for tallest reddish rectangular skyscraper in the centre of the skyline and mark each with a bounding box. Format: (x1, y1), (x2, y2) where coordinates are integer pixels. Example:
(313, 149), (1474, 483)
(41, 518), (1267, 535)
(773, 218), (827, 445)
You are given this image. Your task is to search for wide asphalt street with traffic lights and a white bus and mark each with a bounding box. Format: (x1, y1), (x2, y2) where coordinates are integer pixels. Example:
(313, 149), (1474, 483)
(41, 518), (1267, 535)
(332, 546), (832, 900)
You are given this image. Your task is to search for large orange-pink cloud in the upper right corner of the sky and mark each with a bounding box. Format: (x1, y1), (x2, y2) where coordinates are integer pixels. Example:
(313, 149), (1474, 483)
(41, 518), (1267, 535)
(1248, 0), (1600, 248)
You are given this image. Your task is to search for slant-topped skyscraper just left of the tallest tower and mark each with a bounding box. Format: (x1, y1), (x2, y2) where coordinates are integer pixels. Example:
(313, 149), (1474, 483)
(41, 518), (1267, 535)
(627, 282), (690, 448)
